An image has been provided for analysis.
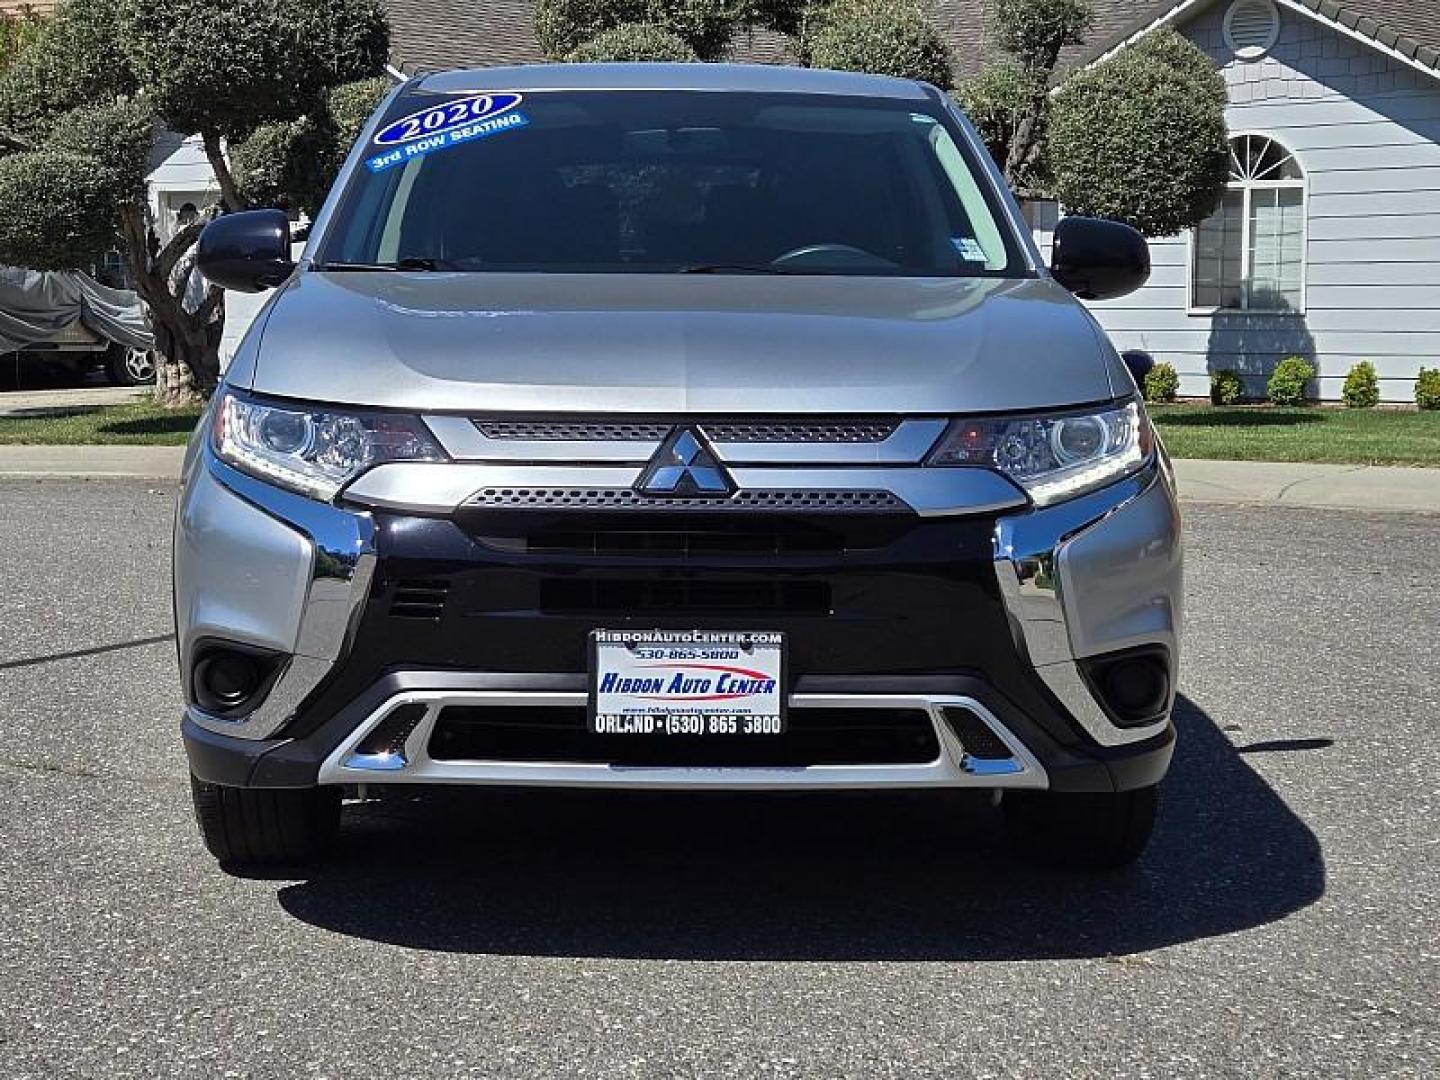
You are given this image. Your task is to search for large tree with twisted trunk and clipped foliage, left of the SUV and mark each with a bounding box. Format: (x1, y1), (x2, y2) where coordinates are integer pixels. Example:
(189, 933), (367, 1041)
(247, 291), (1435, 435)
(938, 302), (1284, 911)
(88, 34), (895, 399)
(0, 0), (387, 403)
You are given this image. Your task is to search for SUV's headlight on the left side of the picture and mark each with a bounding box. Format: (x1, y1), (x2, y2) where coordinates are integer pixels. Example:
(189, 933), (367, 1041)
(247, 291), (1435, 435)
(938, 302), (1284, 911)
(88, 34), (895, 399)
(210, 390), (445, 500)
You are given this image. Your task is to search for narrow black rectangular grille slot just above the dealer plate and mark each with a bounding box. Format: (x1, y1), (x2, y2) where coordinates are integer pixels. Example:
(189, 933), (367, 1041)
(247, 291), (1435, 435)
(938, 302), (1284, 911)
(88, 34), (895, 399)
(540, 577), (831, 616)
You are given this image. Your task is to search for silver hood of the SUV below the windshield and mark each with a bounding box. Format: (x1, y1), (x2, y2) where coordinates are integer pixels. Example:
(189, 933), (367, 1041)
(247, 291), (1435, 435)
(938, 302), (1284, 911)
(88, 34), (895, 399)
(247, 271), (1117, 415)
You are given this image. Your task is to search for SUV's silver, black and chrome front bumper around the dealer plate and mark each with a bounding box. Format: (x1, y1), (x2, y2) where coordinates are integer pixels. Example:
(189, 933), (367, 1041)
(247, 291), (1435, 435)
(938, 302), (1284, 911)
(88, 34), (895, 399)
(176, 454), (1181, 791)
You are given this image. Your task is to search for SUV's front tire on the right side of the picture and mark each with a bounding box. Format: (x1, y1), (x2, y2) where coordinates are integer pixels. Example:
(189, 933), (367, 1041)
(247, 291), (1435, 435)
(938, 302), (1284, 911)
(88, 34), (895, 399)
(1001, 785), (1159, 870)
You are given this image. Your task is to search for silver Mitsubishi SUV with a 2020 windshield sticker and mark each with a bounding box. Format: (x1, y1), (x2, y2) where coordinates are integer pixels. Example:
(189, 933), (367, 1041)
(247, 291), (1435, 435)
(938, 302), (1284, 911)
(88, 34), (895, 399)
(174, 65), (1181, 865)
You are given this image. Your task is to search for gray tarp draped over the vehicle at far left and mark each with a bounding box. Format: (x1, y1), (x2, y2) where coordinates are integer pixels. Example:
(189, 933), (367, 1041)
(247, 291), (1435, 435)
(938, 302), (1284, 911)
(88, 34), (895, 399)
(0, 266), (153, 354)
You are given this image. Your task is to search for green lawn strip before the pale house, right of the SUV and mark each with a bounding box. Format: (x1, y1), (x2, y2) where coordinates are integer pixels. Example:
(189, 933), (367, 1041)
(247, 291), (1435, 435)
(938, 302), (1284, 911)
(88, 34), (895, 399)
(1151, 405), (1440, 467)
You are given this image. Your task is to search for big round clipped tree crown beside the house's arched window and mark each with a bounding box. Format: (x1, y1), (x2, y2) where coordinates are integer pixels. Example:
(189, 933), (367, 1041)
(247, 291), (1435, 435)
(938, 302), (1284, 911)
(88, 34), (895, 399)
(1050, 30), (1230, 236)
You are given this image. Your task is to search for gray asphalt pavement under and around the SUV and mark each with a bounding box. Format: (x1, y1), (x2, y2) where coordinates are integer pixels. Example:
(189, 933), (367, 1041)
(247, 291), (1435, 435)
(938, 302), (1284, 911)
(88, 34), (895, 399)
(0, 480), (1440, 1079)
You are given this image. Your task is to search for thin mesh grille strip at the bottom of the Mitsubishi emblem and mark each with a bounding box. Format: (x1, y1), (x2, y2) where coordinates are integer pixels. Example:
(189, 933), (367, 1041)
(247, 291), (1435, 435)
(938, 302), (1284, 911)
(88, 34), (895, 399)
(465, 488), (910, 514)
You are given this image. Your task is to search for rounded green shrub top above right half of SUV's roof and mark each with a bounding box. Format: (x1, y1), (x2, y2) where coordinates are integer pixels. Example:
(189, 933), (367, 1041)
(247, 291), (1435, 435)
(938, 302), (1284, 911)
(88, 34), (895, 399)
(801, 0), (953, 89)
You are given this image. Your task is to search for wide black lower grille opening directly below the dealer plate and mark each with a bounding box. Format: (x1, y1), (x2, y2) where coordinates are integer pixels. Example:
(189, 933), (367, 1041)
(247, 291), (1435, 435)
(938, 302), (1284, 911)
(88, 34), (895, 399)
(429, 706), (940, 768)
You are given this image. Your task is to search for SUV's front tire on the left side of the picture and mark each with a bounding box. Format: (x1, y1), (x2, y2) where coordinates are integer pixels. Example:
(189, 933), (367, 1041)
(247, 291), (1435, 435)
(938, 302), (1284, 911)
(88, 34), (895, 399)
(190, 776), (340, 867)
